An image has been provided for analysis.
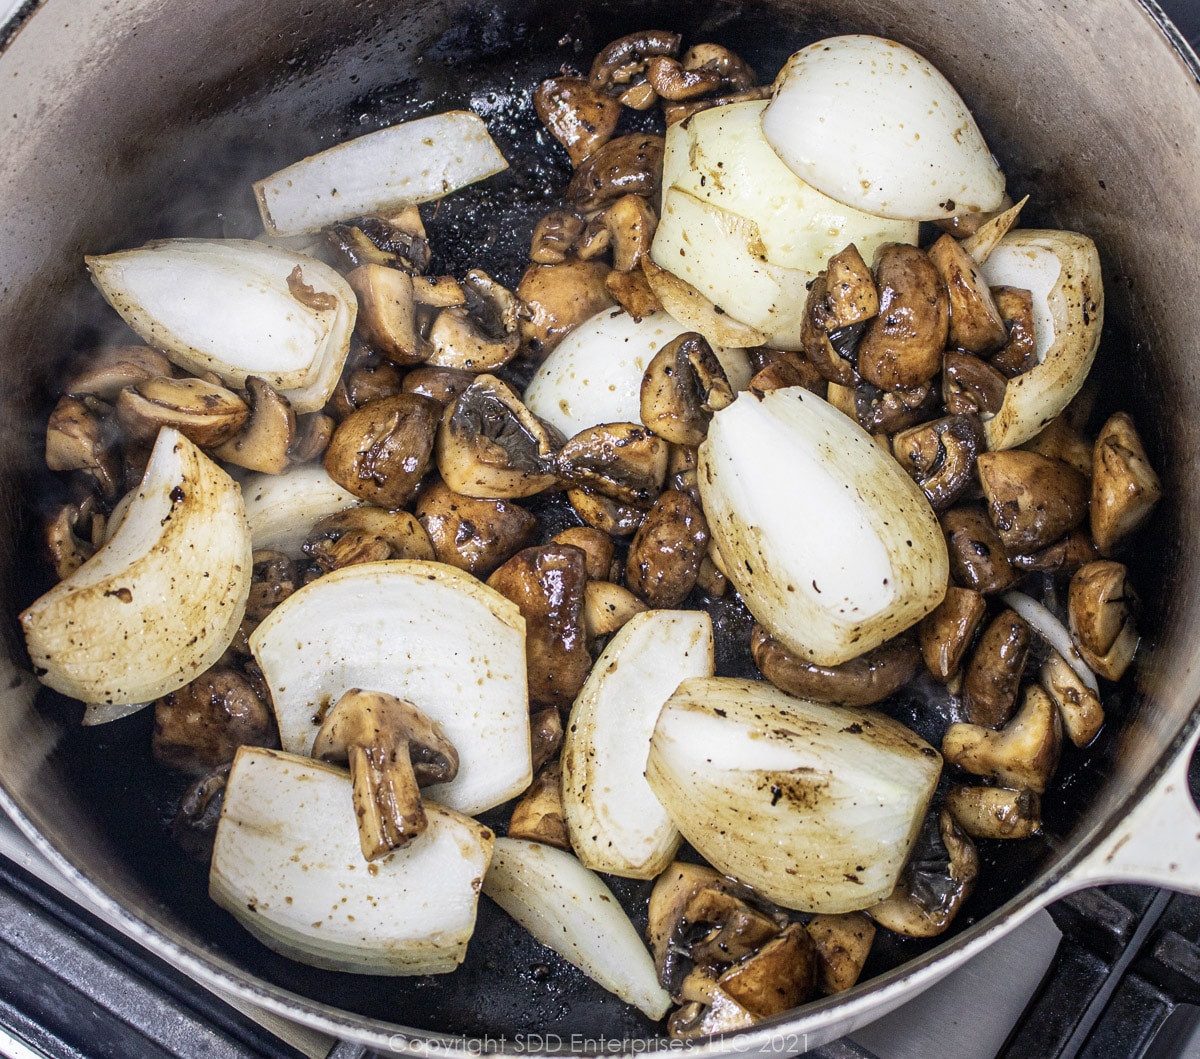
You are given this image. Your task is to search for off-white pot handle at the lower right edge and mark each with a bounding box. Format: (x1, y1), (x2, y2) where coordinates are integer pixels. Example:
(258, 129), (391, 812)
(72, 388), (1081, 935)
(1063, 719), (1200, 895)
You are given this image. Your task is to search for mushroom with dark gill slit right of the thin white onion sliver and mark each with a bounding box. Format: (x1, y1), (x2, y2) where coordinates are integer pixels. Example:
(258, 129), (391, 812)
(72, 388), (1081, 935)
(1067, 560), (1139, 681)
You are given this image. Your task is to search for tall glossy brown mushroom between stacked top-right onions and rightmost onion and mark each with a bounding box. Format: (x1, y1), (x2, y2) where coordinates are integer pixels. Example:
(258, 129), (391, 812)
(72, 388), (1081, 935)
(858, 243), (949, 390)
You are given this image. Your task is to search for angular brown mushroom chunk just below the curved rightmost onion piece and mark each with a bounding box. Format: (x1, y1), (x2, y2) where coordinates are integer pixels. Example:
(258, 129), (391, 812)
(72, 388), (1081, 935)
(978, 449), (1088, 552)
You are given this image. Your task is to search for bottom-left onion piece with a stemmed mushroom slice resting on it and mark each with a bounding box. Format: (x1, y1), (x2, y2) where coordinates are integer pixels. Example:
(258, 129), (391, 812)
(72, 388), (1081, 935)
(209, 747), (493, 975)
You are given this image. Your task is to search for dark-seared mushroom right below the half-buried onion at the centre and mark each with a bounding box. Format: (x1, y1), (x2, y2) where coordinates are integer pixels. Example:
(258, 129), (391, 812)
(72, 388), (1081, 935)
(556, 423), (670, 507)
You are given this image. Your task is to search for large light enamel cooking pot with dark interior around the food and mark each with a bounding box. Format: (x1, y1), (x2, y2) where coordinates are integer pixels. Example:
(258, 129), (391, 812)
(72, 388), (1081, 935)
(0, 0), (1200, 1054)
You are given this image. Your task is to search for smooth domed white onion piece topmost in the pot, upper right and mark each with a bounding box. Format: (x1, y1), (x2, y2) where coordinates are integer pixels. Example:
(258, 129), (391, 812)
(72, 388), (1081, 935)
(762, 35), (1004, 221)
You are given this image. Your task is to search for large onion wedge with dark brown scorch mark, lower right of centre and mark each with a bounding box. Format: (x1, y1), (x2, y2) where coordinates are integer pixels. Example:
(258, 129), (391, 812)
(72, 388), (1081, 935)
(646, 677), (942, 914)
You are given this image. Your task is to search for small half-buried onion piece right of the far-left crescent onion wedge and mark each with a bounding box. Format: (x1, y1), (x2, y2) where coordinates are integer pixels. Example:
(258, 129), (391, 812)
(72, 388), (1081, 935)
(241, 461), (365, 558)
